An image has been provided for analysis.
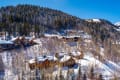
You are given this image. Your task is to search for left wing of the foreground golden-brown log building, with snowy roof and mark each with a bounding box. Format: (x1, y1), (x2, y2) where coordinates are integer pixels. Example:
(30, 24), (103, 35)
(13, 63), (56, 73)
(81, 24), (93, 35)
(29, 56), (58, 70)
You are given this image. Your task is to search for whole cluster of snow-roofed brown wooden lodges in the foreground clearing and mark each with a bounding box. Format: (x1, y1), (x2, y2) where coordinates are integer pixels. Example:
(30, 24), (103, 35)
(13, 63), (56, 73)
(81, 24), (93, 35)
(28, 52), (84, 70)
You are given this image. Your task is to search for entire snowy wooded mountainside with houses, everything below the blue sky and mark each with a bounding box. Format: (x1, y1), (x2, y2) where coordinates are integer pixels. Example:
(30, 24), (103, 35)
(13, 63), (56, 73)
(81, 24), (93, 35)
(0, 5), (120, 80)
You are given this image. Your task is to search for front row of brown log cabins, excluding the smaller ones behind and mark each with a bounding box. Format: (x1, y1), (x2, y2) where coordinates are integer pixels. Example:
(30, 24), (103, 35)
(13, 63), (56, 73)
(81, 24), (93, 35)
(29, 55), (76, 70)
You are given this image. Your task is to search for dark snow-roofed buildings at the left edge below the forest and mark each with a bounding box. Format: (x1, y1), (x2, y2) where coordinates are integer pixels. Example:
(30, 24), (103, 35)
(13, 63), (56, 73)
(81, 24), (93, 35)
(0, 36), (36, 51)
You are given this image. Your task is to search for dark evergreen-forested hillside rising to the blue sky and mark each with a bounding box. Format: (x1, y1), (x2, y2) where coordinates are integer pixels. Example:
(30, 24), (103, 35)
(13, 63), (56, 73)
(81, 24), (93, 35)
(0, 5), (119, 42)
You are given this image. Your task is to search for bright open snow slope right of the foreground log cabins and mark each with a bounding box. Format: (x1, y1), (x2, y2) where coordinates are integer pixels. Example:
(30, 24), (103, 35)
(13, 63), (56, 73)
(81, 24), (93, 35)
(78, 55), (120, 80)
